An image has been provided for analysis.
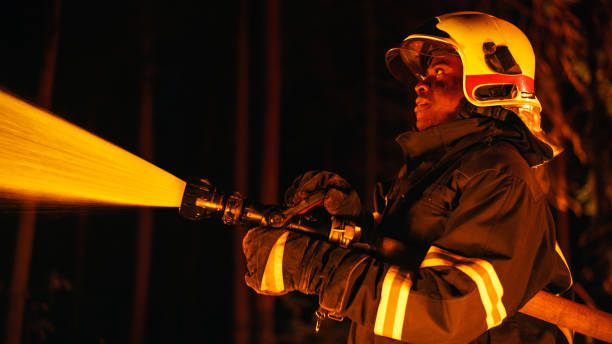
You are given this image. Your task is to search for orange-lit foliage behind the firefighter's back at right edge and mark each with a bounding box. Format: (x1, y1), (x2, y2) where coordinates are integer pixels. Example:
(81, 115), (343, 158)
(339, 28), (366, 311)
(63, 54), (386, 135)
(526, 0), (612, 310)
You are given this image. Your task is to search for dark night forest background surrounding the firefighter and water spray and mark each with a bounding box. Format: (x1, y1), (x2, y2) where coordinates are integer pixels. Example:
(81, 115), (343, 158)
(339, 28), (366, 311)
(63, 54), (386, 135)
(0, 0), (612, 343)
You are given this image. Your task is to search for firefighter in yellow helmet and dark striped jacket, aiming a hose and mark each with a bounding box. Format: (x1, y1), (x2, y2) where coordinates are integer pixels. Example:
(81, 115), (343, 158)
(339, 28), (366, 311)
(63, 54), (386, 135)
(243, 12), (572, 343)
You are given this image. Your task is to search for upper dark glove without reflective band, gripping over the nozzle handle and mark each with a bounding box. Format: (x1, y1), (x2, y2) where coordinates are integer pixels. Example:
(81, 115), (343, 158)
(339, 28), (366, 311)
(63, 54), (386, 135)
(283, 171), (361, 216)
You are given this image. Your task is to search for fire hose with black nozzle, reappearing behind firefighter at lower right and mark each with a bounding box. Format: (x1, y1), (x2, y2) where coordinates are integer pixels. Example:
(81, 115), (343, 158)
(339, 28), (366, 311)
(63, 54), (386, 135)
(179, 179), (612, 343)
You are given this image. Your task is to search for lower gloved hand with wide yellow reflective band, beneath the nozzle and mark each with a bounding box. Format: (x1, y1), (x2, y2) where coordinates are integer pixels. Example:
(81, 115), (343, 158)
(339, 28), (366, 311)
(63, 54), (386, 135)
(242, 227), (371, 312)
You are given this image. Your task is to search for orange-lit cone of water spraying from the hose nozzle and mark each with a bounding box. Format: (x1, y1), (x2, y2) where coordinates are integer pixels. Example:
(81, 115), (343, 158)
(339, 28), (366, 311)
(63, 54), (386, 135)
(0, 91), (185, 207)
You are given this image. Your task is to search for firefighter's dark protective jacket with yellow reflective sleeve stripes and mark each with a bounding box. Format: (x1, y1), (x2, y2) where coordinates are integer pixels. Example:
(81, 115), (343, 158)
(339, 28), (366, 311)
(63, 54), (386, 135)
(245, 110), (572, 344)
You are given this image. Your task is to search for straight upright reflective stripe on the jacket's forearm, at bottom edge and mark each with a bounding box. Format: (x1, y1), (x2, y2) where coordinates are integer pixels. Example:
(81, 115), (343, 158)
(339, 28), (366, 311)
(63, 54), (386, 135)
(374, 266), (412, 340)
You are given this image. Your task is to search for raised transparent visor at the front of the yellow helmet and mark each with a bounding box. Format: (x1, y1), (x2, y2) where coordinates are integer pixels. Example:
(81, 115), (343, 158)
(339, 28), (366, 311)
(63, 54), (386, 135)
(386, 39), (459, 83)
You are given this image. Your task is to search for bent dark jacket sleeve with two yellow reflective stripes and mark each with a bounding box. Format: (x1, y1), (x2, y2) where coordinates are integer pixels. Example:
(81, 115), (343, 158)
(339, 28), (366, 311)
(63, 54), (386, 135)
(312, 169), (556, 343)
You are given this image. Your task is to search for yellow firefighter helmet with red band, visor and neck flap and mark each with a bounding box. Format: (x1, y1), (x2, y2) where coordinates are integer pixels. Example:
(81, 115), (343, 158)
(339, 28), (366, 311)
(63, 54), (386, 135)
(385, 12), (559, 155)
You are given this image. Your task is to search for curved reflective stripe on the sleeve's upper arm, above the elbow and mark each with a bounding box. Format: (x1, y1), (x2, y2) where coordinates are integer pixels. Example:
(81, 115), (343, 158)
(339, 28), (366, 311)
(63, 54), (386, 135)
(421, 246), (507, 328)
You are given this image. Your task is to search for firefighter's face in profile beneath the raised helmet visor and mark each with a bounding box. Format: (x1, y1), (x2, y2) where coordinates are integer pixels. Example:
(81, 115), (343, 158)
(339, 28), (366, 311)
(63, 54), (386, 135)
(414, 55), (463, 130)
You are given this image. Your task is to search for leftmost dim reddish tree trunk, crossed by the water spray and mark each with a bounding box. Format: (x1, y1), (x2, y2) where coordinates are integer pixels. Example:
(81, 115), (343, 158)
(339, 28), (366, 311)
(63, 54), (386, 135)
(6, 0), (61, 344)
